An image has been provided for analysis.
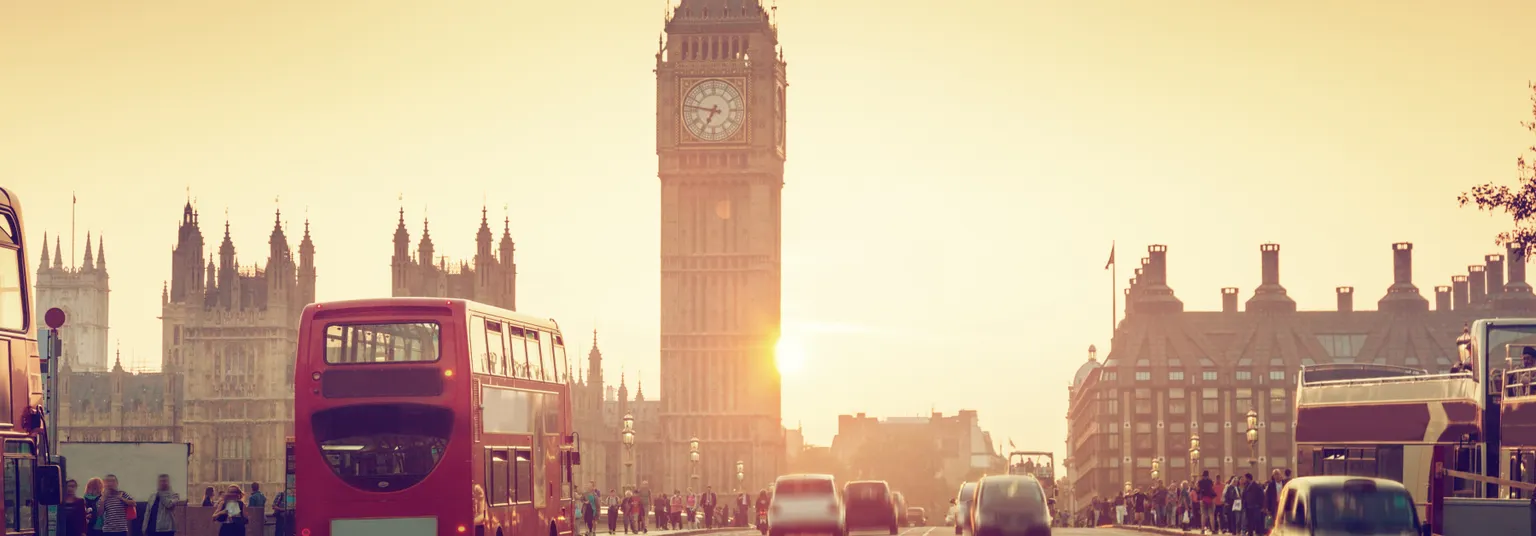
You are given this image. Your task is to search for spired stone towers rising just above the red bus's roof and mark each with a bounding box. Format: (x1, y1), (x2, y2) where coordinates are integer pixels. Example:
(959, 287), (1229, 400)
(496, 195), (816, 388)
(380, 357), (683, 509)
(390, 207), (518, 310)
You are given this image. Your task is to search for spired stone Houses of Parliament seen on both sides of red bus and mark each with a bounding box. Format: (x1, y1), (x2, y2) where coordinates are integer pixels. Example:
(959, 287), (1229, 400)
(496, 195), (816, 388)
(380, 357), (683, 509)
(35, 203), (678, 488)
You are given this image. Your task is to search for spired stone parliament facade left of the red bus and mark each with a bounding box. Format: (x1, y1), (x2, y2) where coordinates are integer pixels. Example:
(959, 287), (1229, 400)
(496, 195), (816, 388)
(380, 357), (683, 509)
(38, 203), (315, 490)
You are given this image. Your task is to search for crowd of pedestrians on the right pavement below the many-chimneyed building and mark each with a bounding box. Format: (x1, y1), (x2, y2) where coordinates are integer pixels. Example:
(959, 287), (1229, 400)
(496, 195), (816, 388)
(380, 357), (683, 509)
(1074, 468), (1290, 536)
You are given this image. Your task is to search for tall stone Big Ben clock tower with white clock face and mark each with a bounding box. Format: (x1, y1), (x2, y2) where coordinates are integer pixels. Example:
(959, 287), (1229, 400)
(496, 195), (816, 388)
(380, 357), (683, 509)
(654, 0), (788, 491)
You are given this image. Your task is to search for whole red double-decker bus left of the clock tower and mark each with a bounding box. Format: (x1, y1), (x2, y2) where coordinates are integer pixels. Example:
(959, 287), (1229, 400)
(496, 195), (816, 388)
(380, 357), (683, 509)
(293, 298), (581, 536)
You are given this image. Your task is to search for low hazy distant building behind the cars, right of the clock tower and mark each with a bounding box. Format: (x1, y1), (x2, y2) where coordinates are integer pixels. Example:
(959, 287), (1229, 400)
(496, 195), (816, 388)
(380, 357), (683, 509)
(833, 410), (1005, 487)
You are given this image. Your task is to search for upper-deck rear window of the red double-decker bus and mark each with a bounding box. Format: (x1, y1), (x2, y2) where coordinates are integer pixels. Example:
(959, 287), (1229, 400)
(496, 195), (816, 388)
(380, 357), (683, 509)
(326, 323), (442, 364)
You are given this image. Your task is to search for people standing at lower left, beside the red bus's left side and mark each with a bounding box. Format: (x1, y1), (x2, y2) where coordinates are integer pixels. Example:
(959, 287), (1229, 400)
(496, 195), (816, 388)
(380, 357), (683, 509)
(58, 475), (292, 536)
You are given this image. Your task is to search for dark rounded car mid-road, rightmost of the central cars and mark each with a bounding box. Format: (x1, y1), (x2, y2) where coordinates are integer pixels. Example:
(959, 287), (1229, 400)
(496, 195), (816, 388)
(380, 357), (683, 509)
(971, 475), (1051, 536)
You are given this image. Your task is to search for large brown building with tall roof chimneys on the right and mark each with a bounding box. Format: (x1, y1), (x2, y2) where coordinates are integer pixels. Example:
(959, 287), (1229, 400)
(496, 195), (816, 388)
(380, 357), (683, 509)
(1066, 243), (1536, 507)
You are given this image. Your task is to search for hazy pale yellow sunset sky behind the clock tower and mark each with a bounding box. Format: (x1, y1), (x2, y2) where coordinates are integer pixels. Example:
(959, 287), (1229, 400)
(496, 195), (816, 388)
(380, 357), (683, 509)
(0, 0), (1536, 463)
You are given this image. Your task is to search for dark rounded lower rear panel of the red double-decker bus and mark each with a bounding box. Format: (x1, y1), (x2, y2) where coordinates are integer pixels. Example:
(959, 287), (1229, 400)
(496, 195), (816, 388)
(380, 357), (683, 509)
(310, 404), (453, 491)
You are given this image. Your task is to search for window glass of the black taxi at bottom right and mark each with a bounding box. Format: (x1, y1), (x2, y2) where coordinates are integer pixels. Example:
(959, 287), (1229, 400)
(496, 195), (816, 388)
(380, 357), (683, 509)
(1312, 488), (1419, 534)
